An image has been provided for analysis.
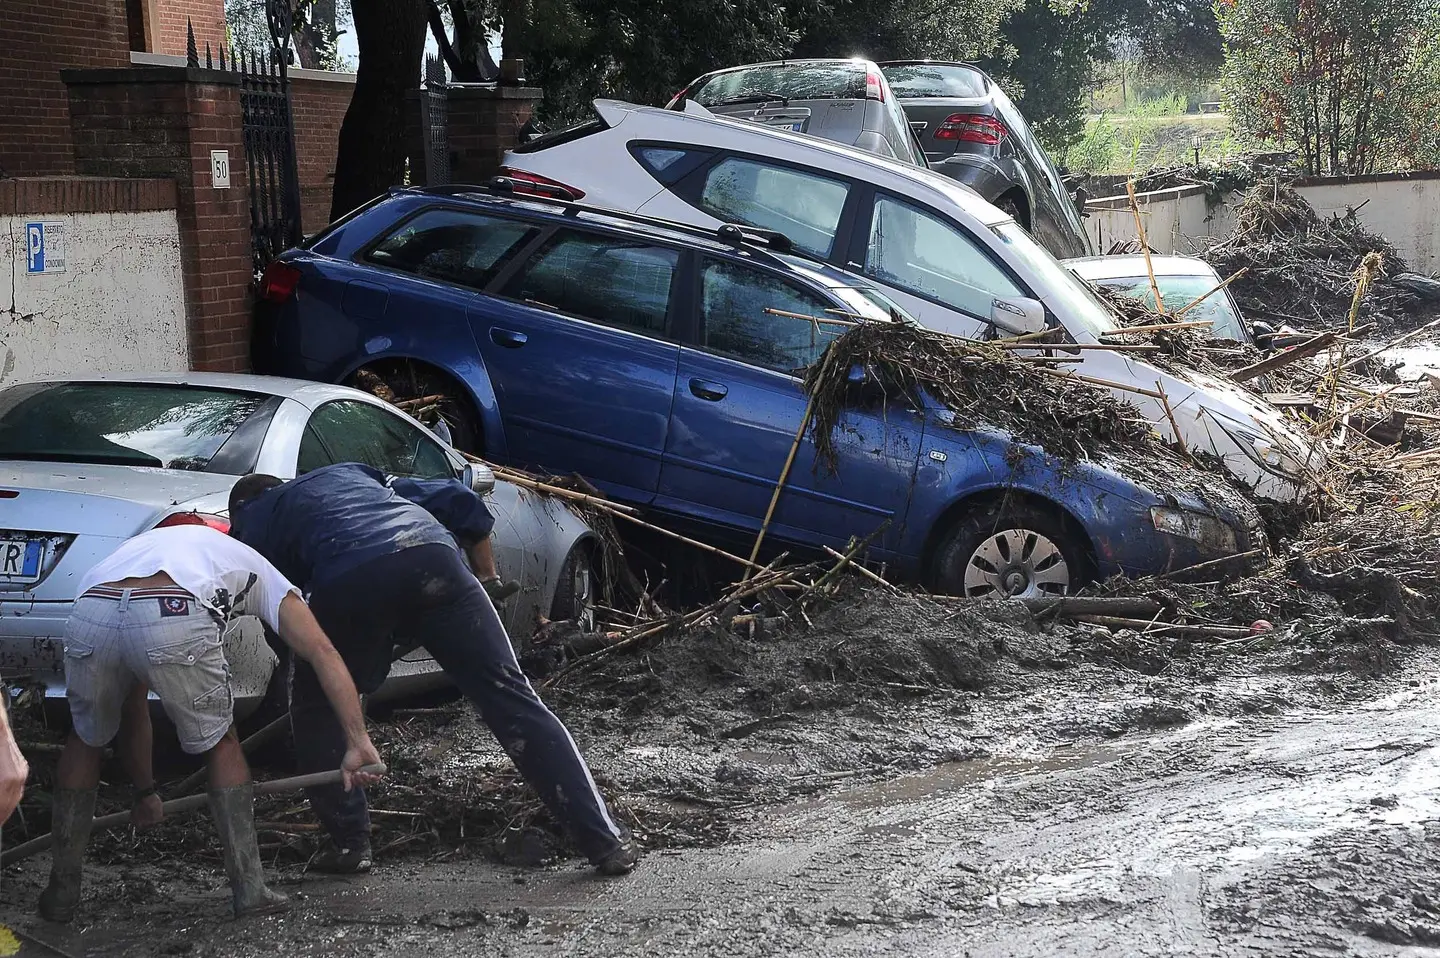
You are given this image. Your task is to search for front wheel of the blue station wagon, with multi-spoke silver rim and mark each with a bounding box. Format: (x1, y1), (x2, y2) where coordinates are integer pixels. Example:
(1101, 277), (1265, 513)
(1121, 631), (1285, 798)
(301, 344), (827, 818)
(932, 501), (1093, 598)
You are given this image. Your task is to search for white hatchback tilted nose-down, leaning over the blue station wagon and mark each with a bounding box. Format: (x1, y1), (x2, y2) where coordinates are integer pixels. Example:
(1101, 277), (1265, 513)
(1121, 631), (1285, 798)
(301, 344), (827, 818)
(501, 99), (1323, 500)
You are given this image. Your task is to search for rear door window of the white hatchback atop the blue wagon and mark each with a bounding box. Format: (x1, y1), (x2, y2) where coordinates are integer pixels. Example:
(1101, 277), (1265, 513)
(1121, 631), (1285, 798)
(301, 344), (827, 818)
(700, 157), (850, 258)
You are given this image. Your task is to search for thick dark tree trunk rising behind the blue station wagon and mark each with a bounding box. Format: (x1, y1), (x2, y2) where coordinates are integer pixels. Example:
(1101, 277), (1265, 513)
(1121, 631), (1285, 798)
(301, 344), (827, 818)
(330, 0), (425, 220)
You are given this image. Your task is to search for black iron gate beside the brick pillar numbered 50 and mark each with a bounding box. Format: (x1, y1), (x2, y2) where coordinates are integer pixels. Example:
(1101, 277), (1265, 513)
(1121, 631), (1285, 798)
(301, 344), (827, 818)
(187, 0), (304, 277)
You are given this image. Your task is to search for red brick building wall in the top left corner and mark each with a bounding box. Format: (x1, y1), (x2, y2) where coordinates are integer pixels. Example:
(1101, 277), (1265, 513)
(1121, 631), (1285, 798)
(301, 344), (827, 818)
(0, 0), (131, 176)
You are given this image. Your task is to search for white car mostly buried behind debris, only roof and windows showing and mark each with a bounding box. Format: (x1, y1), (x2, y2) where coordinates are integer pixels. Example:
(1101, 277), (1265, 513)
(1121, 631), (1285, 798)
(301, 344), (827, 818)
(1060, 254), (1254, 343)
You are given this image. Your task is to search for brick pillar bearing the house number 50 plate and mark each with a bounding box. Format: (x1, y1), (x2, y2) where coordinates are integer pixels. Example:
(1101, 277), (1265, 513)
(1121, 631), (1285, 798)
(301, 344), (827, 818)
(60, 66), (252, 372)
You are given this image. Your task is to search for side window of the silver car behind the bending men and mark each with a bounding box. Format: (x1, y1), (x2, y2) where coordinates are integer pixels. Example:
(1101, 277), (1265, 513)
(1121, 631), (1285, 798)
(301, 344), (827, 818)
(295, 399), (455, 478)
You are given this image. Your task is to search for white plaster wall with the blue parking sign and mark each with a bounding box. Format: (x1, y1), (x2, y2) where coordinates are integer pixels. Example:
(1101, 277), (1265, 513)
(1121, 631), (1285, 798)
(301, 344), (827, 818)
(0, 210), (190, 385)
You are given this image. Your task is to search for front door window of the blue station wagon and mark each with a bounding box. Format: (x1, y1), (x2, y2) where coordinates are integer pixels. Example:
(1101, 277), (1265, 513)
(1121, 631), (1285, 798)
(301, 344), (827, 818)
(700, 261), (845, 373)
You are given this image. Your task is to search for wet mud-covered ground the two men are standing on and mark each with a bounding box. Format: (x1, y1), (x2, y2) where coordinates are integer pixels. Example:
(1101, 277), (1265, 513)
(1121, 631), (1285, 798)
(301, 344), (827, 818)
(0, 592), (1440, 957)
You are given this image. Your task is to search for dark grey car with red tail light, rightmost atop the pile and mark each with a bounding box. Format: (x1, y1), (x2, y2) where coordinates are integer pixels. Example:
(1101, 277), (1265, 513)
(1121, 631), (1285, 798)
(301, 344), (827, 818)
(880, 61), (1092, 259)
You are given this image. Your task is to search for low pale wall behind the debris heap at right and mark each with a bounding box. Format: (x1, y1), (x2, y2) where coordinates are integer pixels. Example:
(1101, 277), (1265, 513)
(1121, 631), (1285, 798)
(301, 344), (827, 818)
(1084, 177), (1440, 266)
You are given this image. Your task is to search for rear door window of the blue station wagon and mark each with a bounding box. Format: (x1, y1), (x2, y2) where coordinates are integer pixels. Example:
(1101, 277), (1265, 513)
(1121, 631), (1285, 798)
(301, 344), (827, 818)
(504, 230), (680, 336)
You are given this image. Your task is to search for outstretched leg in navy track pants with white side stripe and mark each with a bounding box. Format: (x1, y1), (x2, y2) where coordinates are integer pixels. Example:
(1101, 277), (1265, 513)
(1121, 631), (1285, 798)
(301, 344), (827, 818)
(400, 547), (634, 873)
